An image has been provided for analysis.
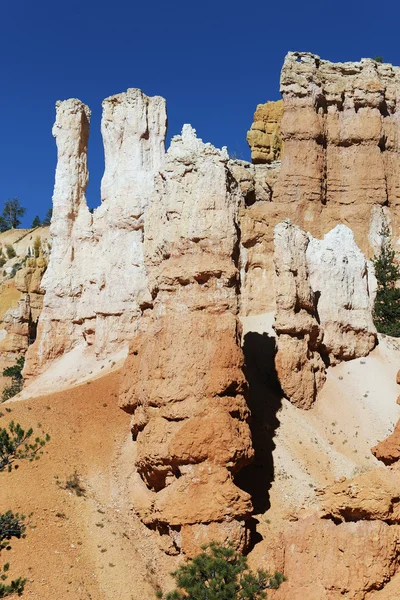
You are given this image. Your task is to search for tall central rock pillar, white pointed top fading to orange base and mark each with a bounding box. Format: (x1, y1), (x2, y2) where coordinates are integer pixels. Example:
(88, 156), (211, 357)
(121, 126), (253, 555)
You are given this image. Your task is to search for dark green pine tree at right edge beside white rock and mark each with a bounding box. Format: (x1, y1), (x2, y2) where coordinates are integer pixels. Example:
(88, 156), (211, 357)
(372, 225), (400, 337)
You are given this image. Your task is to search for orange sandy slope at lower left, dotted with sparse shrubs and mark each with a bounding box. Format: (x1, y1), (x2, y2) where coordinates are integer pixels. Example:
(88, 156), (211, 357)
(0, 372), (176, 600)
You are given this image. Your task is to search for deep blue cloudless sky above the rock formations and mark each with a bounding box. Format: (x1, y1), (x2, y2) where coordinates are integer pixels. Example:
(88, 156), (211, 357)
(0, 0), (400, 226)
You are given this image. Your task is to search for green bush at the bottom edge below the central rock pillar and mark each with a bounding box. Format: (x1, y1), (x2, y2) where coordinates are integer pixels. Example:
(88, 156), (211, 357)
(157, 543), (286, 600)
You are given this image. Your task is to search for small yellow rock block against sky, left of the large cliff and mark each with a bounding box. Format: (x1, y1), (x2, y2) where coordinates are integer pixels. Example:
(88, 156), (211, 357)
(247, 100), (283, 164)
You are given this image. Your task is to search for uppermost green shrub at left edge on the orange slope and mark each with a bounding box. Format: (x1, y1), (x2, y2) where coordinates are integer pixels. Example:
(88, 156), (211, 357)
(0, 421), (50, 473)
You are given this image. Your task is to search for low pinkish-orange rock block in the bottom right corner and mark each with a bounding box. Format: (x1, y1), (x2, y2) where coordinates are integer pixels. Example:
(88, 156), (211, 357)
(271, 516), (400, 600)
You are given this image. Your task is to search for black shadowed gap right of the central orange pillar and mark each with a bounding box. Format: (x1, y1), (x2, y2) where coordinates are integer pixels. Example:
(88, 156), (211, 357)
(235, 332), (283, 515)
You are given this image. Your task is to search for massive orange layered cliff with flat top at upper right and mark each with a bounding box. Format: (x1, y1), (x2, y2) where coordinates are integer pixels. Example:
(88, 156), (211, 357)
(242, 52), (400, 314)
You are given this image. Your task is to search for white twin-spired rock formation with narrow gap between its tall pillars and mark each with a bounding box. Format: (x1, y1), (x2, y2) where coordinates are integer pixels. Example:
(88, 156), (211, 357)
(25, 89), (166, 375)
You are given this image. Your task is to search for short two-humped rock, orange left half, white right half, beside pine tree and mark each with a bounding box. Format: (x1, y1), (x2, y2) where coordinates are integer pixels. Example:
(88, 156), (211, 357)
(274, 221), (376, 408)
